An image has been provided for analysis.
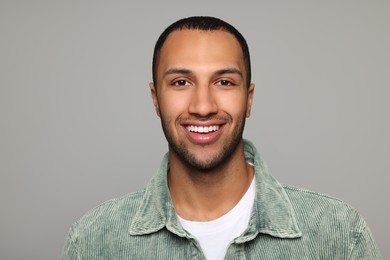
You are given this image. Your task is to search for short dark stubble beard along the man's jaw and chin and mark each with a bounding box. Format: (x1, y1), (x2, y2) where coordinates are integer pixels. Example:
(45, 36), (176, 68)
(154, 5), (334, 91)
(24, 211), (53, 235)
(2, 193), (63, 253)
(160, 113), (246, 172)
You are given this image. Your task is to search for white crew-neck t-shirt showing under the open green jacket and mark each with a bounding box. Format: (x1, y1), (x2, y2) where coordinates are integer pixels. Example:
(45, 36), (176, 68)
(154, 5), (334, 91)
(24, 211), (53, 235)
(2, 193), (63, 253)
(179, 178), (256, 260)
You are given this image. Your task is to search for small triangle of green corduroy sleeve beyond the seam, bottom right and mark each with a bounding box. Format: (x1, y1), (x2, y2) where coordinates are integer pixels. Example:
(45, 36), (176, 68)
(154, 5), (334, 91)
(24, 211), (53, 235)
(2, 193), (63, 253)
(349, 222), (383, 260)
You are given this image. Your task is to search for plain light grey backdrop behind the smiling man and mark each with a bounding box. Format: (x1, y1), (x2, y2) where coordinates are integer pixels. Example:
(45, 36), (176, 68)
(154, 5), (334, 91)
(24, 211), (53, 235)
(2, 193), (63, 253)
(0, 0), (390, 259)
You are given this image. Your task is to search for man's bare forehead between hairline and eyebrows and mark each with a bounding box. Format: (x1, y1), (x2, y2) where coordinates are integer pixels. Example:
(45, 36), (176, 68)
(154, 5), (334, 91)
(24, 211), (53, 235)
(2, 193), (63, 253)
(157, 29), (244, 72)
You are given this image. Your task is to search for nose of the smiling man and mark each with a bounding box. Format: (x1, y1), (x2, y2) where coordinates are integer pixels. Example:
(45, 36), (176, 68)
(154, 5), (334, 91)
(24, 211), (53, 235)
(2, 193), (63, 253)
(188, 84), (218, 117)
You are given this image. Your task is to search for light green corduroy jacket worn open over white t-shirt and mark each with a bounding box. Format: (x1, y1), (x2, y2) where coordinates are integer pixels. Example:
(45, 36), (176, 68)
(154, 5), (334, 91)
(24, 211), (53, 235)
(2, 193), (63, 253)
(62, 140), (382, 260)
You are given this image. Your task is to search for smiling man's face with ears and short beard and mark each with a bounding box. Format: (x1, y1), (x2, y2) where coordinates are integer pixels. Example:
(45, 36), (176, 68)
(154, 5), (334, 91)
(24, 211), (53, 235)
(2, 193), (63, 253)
(150, 30), (254, 171)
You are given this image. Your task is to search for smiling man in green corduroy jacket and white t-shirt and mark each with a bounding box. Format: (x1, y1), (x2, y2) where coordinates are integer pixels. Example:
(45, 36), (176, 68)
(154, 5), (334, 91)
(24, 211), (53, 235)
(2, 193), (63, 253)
(62, 17), (381, 259)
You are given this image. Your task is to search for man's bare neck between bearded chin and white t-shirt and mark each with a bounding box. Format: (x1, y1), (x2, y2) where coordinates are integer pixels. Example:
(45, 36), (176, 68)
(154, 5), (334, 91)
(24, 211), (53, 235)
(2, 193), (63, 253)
(168, 141), (254, 221)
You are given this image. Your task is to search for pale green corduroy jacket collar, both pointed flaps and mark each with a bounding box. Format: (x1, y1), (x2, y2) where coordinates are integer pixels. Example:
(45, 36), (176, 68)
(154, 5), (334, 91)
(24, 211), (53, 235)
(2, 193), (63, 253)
(129, 140), (301, 240)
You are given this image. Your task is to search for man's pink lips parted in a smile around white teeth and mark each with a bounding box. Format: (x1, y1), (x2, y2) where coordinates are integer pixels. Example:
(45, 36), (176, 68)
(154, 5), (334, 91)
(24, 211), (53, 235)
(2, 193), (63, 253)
(182, 120), (225, 145)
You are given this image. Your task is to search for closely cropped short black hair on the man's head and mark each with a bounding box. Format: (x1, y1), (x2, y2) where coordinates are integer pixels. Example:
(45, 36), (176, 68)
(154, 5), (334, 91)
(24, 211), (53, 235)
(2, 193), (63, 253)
(152, 16), (251, 87)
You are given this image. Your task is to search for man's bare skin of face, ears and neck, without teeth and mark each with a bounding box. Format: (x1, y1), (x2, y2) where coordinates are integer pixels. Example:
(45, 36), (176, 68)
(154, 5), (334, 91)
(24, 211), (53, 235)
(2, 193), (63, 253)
(150, 30), (254, 221)
